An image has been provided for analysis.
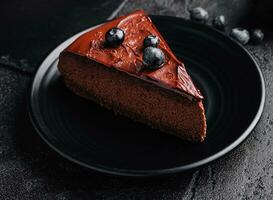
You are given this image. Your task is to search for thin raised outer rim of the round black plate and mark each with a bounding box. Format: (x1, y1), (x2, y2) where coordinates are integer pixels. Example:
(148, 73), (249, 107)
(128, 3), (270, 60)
(27, 15), (265, 177)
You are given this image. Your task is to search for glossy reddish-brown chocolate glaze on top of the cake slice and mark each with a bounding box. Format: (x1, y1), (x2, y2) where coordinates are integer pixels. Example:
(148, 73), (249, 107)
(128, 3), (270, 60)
(65, 10), (203, 100)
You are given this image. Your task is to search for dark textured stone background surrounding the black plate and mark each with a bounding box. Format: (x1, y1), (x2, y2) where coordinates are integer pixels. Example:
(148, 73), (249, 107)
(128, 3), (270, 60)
(0, 0), (273, 200)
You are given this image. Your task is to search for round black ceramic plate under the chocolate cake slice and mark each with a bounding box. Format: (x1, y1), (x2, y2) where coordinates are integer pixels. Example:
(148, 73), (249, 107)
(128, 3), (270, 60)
(29, 16), (265, 176)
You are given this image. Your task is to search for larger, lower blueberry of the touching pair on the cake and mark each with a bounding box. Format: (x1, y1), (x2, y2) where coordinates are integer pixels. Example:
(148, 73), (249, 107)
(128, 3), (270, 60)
(143, 47), (165, 70)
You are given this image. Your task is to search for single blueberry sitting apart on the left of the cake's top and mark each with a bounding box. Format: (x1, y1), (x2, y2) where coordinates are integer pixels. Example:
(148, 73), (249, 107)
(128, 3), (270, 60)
(105, 28), (125, 47)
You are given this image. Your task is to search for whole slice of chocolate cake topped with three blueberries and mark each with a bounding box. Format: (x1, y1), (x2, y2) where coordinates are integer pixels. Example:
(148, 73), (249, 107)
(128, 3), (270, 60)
(58, 11), (206, 142)
